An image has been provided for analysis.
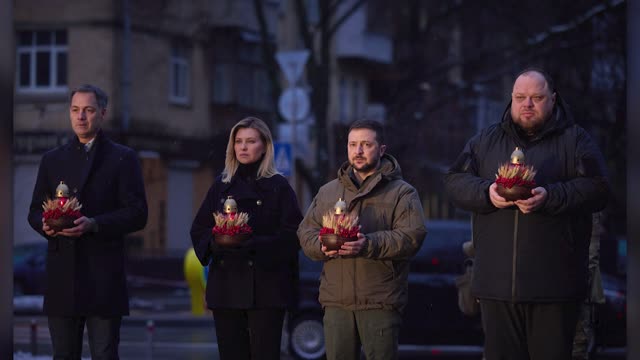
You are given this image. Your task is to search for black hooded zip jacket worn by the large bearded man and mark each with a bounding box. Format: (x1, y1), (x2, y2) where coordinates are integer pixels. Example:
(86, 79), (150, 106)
(445, 95), (609, 303)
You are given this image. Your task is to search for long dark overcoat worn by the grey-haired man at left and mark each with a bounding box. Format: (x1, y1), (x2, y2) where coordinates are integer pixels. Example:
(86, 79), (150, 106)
(29, 131), (147, 316)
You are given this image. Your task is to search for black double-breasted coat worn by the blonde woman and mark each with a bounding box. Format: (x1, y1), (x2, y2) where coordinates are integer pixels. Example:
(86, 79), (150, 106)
(191, 175), (302, 309)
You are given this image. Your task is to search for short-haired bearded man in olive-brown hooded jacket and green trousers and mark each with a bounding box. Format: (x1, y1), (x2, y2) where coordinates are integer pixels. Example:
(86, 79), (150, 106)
(298, 120), (426, 360)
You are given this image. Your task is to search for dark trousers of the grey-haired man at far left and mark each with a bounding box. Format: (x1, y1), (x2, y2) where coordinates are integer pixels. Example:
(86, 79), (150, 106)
(48, 316), (122, 360)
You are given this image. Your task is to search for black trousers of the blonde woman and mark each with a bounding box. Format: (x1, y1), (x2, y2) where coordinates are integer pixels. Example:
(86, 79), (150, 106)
(213, 309), (285, 360)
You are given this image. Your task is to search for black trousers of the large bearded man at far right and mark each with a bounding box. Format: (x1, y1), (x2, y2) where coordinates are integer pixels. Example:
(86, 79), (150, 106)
(480, 300), (580, 360)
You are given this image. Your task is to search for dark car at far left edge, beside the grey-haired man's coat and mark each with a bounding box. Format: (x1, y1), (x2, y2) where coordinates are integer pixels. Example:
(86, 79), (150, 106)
(13, 241), (47, 296)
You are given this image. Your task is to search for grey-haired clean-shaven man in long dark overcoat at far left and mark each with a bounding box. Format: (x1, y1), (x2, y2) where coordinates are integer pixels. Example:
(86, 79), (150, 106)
(29, 85), (147, 359)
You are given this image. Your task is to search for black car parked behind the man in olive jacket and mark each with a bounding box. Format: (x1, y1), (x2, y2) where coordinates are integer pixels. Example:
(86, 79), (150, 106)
(285, 221), (626, 359)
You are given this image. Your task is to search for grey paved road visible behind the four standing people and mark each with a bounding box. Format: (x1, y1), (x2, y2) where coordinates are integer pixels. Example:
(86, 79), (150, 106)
(14, 289), (625, 360)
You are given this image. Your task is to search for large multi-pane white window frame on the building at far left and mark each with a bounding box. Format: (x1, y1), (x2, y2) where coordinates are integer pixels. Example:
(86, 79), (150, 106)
(15, 30), (69, 93)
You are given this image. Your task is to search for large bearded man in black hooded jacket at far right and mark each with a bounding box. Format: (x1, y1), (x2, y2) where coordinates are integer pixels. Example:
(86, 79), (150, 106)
(445, 69), (609, 360)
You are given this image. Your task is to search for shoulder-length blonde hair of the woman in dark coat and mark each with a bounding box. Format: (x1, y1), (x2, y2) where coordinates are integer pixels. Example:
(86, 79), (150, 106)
(222, 116), (279, 183)
